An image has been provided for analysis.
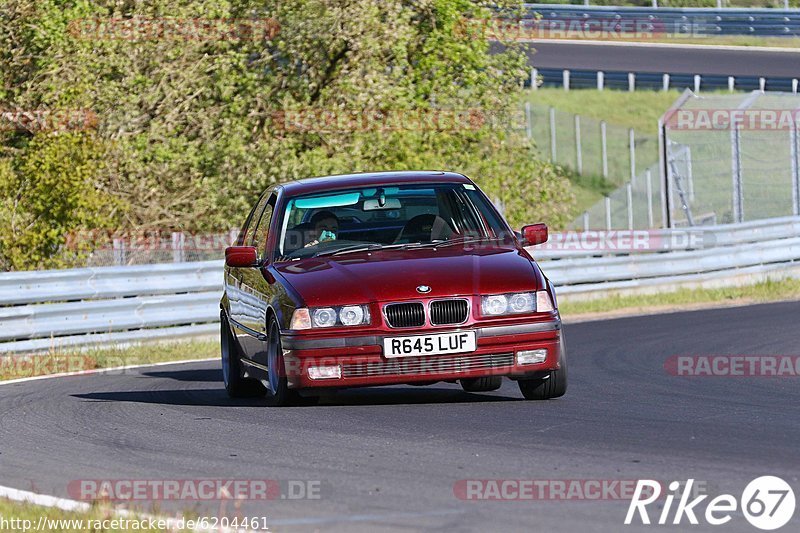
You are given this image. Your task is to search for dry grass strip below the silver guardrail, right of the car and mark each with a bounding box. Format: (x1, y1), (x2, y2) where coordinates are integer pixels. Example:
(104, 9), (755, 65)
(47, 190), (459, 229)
(559, 279), (800, 320)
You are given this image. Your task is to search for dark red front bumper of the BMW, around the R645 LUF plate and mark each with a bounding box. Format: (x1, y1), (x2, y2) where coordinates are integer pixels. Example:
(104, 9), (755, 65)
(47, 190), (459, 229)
(283, 318), (563, 389)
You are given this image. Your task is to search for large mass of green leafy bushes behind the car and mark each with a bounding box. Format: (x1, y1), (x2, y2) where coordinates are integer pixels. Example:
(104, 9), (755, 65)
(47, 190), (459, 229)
(0, 0), (573, 268)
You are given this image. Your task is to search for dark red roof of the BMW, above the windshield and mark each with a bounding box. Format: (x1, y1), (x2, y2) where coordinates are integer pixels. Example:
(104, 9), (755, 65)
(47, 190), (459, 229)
(279, 170), (472, 196)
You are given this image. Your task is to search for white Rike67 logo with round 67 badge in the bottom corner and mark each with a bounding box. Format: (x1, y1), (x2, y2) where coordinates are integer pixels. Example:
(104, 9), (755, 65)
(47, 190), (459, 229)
(625, 476), (795, 531)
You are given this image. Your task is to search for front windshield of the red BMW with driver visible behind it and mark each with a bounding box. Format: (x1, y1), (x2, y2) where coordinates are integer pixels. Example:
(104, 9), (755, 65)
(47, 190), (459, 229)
(275, 183), (508, 261)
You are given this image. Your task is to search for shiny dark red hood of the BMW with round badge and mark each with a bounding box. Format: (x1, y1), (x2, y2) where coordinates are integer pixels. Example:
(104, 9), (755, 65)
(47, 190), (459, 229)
(276, 246), (544, 307)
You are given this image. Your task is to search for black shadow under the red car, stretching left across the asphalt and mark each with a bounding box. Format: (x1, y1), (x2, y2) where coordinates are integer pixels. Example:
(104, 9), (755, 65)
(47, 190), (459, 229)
(73, 383), (522, 408)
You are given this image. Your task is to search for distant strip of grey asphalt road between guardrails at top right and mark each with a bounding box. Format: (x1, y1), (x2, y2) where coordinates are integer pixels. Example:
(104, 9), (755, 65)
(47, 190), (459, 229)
(529, 41), (800, 78)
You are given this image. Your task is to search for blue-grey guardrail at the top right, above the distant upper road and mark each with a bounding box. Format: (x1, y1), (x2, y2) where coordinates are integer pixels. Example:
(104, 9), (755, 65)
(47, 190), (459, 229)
(526, 4), (800, 37)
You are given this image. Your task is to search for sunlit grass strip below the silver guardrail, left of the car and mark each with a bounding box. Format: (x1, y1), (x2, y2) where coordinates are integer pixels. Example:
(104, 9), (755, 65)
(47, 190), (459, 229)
(0, 340), (219, 381)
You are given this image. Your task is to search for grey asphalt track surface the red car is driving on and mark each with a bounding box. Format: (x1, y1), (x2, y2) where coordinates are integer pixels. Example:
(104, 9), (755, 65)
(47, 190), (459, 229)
(0, 302), (800, 532)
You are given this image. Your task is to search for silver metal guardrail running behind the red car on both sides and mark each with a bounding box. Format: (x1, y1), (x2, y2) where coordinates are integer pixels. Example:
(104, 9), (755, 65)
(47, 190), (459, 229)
(0, 217), (800, 353)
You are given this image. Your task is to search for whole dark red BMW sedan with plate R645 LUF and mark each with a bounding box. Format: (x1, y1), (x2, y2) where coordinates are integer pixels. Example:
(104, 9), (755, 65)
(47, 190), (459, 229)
(220, 172), (567, 405)
